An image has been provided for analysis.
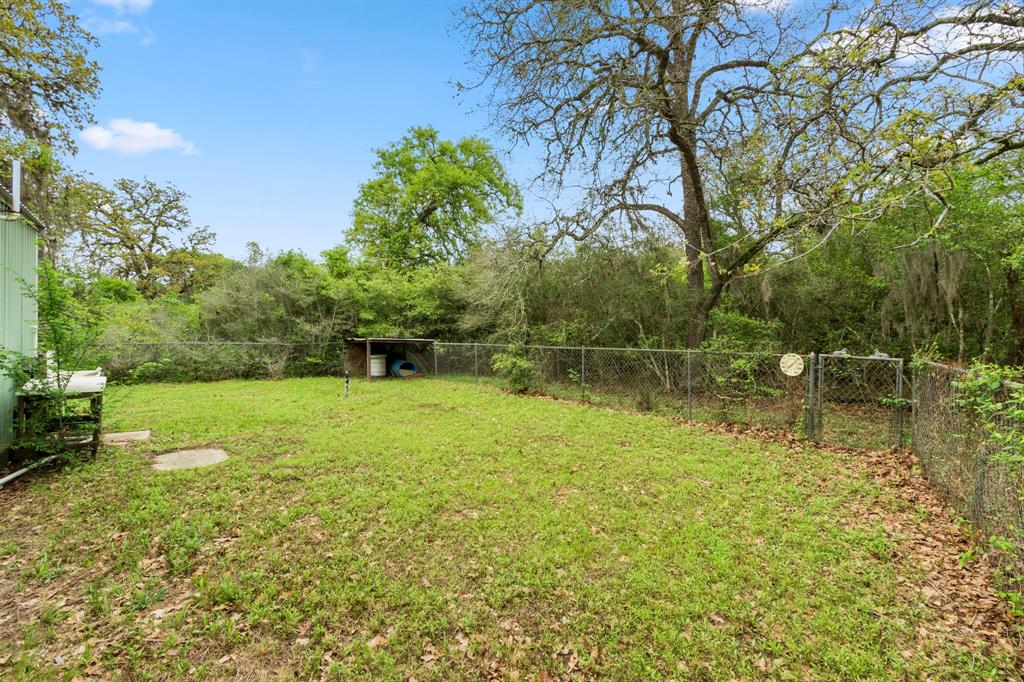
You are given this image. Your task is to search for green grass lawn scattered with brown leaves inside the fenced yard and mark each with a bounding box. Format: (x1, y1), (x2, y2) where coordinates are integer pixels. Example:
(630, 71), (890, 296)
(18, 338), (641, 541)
(0, 379), (1013, 680)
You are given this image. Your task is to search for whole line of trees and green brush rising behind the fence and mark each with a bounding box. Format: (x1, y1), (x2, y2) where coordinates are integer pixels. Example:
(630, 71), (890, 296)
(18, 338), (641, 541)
(0, 0), (1024, 364)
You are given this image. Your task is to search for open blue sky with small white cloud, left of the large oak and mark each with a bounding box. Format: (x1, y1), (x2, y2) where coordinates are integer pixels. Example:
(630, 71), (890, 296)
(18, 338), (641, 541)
(71, 0), (516, 257)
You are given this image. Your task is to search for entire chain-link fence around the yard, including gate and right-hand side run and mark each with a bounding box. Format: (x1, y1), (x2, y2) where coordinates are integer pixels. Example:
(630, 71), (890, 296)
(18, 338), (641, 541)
(39, 341), (1024, 593)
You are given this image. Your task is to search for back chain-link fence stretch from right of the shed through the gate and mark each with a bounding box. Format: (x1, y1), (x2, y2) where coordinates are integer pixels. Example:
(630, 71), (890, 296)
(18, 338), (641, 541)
(431, 343), (904, 449)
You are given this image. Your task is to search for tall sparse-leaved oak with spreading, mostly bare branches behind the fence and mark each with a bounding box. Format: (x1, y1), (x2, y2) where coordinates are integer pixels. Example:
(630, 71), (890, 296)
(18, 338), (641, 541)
(461, 0), (1024, 345)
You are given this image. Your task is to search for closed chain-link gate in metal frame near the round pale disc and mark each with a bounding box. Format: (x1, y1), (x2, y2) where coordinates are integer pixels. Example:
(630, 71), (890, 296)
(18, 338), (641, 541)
(815, 353), (906, 450)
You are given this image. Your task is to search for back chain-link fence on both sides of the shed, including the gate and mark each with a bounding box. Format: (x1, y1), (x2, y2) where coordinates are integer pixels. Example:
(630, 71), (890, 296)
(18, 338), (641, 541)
(82, 341), (907, 449)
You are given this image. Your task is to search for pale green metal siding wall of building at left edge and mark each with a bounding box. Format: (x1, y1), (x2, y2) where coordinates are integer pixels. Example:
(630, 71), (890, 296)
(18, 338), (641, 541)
(0, 212), (39, 451)
